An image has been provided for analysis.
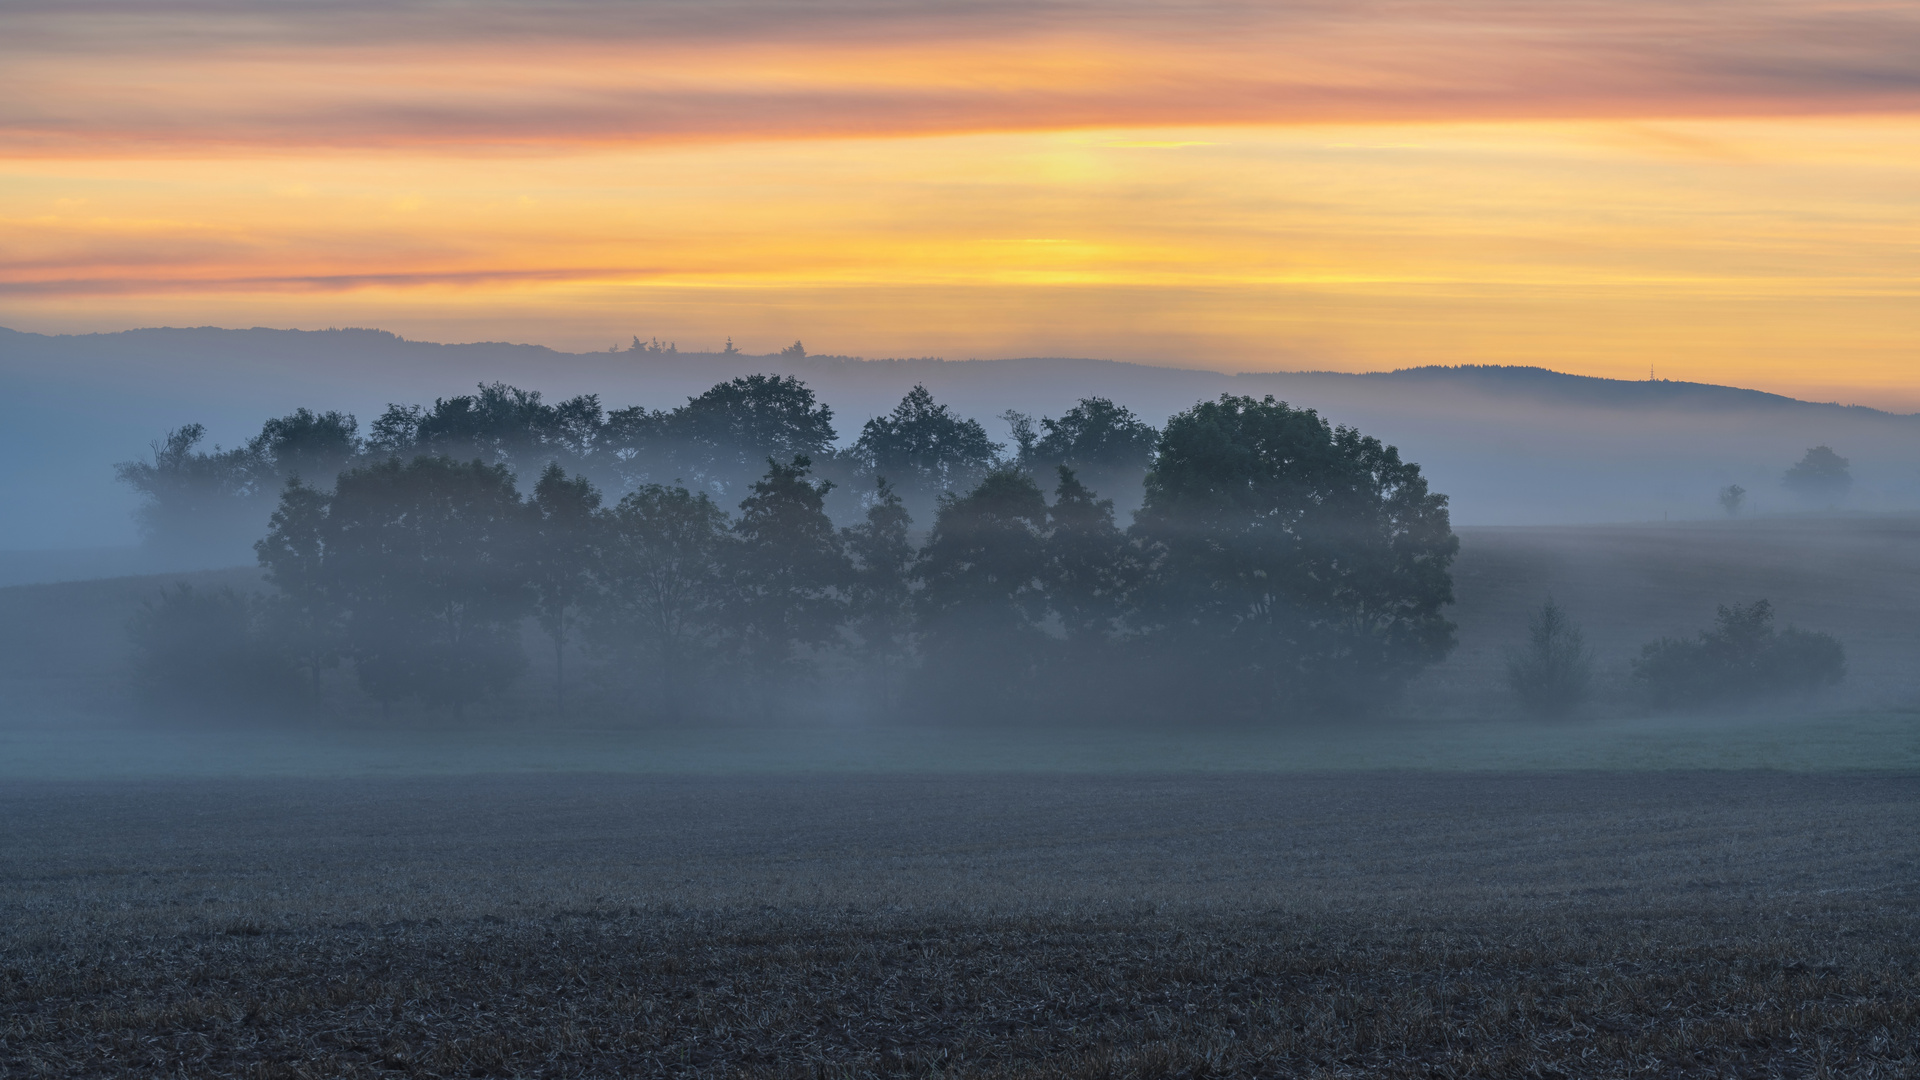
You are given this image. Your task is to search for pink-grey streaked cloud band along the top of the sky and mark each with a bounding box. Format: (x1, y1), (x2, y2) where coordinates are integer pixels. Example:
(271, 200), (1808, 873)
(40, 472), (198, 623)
(11, 0), (1920, 156)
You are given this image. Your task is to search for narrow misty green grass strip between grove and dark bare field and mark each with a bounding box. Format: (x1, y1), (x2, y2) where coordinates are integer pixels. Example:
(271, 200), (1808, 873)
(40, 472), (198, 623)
(0, 711), (1920, 780)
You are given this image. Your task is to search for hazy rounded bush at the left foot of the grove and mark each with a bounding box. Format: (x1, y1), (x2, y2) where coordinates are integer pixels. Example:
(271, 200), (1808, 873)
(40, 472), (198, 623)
(129, 582), (298, 709)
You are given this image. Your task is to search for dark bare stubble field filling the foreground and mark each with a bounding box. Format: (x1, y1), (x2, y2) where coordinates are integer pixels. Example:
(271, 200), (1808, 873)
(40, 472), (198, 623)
(0, 773), (1920, 1078)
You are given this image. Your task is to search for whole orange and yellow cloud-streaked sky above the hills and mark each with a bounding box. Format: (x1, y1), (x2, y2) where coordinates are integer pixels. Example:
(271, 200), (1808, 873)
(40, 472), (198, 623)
(0, 0), (1920, 411)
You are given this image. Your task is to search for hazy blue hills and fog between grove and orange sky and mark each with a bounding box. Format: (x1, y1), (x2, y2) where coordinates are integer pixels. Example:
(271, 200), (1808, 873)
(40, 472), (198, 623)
(0, 329), (1920, 557)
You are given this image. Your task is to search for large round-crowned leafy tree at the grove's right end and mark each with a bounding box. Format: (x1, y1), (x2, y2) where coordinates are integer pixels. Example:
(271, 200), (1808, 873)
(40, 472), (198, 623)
(1135, 396), (1459, 709)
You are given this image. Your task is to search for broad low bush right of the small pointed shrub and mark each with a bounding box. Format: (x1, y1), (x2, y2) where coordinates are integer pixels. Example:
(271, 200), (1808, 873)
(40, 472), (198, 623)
(1634, 600), (1847, 705)
